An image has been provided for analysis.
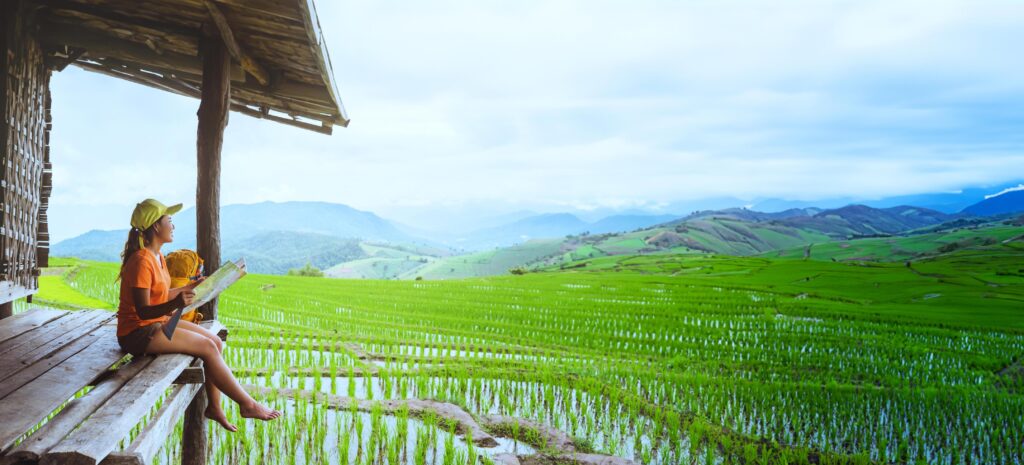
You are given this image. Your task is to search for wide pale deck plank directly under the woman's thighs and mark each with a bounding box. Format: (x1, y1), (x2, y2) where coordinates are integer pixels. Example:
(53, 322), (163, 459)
(40, 353), (194, 465)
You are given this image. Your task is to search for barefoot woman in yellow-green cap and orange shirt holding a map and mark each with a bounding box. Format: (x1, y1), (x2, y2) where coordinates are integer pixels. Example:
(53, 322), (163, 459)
(117, 199), (281, 432)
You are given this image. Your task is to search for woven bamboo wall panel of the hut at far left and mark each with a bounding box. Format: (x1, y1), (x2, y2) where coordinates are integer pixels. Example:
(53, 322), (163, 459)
(0, 1), (50, 302)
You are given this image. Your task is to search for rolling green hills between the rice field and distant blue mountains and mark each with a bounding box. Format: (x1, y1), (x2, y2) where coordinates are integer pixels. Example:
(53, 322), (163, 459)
(389, 209), (1024, 279)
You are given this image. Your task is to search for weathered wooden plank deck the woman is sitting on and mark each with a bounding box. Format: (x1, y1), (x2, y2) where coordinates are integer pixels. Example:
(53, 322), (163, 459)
(0, 308), (226, 465)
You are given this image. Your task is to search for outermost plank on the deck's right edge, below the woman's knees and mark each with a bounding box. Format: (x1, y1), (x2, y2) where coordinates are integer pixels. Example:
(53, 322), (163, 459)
(100, 384), (203, 465)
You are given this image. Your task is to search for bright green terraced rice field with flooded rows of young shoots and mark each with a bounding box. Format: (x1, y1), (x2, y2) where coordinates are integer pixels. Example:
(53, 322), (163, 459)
(22, 250), (1024, 465)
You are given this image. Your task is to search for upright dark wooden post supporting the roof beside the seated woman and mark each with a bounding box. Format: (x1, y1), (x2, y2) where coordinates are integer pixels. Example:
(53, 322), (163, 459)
(181, 27), (231, 465)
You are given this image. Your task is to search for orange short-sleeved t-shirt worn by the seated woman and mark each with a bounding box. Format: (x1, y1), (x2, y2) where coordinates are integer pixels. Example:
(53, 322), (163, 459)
(118, 249), (171, 336)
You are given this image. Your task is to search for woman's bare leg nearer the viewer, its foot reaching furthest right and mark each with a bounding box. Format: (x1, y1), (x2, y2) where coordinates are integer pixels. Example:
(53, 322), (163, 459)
(146, 324), (281, 420)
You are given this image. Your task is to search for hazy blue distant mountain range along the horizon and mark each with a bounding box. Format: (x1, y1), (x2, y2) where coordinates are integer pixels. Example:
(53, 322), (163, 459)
(51, 181), (1024, 278)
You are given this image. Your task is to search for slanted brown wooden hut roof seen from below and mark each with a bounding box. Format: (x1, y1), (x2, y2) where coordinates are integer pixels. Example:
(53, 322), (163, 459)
(35, 0), (348, 134)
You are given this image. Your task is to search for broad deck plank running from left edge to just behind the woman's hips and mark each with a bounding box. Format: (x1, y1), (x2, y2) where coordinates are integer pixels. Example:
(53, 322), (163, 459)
(0, 338), (124, 454)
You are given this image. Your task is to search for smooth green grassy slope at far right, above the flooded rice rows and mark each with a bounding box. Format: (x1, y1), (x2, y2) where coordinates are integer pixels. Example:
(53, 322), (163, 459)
(538, 242), (1024, 330)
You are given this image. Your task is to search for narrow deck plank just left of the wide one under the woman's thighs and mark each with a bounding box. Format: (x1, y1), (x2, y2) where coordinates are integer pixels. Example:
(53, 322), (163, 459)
(0, 356), (155, 465)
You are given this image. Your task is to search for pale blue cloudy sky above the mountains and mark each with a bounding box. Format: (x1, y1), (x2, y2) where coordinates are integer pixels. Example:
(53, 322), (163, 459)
(50, 0), (1024, 241)
